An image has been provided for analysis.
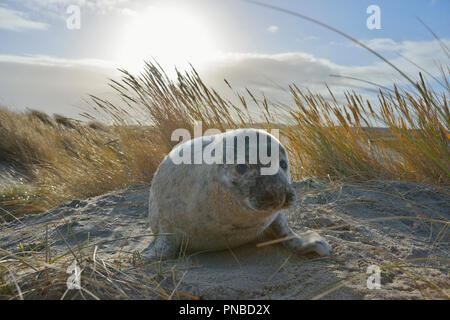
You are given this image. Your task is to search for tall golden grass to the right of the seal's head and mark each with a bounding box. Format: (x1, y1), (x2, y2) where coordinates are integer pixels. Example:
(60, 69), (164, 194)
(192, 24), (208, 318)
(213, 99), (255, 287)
(286, 78), (450, 185)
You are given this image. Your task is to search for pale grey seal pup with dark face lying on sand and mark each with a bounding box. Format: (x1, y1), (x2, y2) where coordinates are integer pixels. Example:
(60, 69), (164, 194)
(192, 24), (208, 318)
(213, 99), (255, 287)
(144, 129), (331, 259)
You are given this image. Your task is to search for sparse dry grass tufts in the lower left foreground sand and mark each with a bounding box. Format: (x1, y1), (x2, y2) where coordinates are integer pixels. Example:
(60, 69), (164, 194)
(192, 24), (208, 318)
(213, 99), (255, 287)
(0, 232), (184, 300)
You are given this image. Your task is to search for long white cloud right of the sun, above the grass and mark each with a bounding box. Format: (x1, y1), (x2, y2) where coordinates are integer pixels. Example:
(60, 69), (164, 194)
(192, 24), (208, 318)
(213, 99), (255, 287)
(199, 39), (450, 101)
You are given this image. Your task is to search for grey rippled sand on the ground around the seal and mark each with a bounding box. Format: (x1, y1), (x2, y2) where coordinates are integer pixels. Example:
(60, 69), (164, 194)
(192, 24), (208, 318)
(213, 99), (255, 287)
(0, 179), (450, 299)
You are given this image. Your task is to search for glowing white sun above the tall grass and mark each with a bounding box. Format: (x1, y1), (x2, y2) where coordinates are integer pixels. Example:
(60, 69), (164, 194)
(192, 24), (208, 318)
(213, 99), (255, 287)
(116, 6), (216, 71)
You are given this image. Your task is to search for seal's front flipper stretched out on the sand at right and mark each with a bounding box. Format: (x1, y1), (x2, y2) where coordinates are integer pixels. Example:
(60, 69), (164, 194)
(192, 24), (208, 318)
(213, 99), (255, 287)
(268, 212), (331, 256)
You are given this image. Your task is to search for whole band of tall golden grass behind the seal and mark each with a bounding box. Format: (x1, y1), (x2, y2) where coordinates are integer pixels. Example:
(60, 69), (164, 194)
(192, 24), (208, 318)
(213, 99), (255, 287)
(0, 63), (450, 219)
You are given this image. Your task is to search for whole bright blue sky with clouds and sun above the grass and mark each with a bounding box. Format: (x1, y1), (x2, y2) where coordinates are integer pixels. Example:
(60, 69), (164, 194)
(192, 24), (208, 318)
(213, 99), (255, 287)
(0, 0), (450, 118)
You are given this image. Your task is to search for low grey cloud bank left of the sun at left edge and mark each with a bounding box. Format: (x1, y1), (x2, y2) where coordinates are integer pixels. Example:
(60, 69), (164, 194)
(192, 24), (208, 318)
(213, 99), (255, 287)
(0, 55), (117, 118)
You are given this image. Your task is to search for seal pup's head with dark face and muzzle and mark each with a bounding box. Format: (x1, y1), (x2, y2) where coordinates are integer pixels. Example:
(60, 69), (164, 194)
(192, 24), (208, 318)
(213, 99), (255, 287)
(219, 129), (295, 212)
